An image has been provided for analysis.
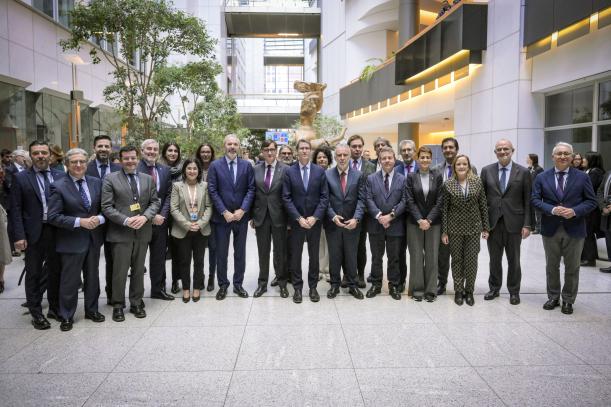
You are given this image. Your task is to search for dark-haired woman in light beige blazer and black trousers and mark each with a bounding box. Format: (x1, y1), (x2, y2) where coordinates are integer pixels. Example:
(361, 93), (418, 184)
(170, 159), (212, 303)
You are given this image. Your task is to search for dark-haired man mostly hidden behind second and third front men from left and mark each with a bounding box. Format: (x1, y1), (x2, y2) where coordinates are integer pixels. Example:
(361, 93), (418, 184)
(85, 134), (121, 305)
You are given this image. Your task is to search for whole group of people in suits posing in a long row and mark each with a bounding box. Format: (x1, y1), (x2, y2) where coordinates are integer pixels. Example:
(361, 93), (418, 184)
(0, 135), (611, 331)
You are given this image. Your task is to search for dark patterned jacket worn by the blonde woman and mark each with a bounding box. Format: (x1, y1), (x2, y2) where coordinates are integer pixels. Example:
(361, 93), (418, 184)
(442, 176), (490, 235)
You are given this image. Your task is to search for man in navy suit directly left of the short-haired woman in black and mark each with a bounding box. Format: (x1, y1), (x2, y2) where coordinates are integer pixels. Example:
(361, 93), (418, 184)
(367, 147), (405, 300)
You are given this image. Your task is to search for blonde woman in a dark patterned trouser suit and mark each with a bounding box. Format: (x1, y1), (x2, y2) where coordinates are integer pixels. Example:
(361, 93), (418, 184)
(441, 154), (490, 306)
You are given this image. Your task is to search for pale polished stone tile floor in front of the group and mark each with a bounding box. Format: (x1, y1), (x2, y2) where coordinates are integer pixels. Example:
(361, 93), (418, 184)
(0, 232), (611, 406)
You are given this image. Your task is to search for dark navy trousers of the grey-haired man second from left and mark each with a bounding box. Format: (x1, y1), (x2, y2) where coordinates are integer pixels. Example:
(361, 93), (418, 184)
(59, 244), (100, 320)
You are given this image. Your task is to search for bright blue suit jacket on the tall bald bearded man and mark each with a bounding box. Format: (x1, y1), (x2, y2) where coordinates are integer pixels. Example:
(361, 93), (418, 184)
(208, 156), (255, 223)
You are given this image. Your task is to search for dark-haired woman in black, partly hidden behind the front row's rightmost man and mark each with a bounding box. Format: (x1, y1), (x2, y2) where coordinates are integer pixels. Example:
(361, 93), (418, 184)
(581, 151), (605, 267)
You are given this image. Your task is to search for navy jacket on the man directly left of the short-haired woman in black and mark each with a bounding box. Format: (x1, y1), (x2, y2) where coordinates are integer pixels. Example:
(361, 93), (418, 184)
(366, 170), (405, 236)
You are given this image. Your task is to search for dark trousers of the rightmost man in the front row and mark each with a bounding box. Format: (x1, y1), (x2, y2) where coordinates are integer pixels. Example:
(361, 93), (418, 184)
(543, 226), (584, 304)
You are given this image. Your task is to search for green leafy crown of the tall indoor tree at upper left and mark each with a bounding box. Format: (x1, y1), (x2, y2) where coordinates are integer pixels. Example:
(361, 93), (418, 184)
(60, 0), (220, 139)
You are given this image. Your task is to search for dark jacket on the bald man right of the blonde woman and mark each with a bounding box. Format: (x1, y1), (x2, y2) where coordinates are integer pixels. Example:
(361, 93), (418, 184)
(481, 162), (532, 233)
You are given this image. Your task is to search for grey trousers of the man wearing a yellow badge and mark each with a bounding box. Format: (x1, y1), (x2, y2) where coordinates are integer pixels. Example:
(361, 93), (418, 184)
(112, 241), (148, 308)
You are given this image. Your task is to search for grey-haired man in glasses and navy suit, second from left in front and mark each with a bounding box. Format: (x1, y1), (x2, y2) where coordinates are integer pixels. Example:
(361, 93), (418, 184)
(48, 148), (105, 331)
